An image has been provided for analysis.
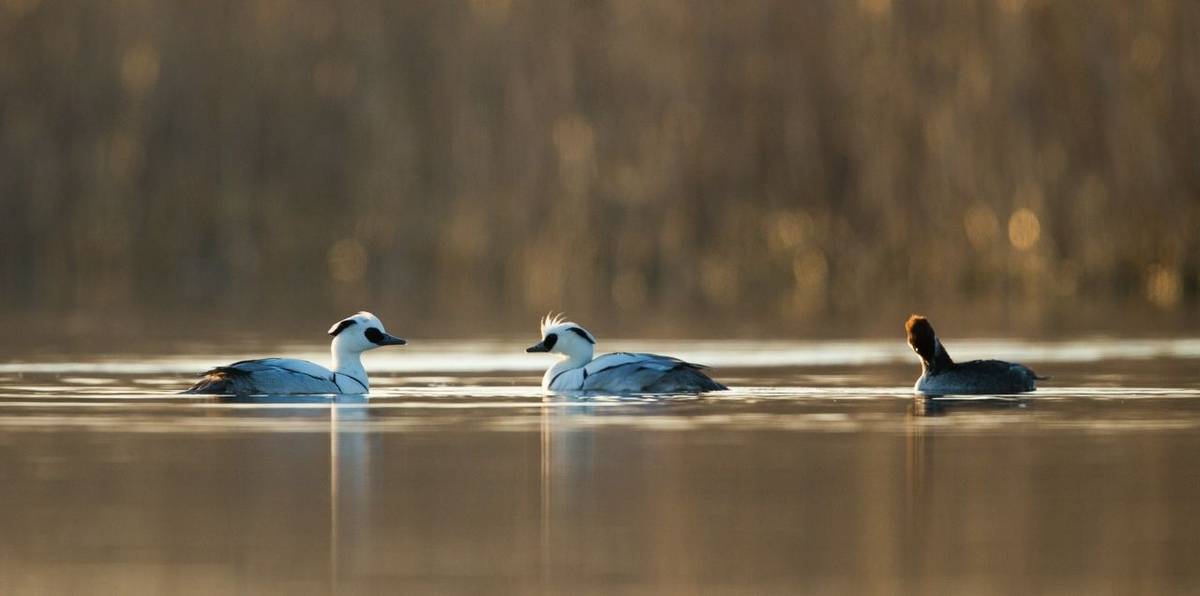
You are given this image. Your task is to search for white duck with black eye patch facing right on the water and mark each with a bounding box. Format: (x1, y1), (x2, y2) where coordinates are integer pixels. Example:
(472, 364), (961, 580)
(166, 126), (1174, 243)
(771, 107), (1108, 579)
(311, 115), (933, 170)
(185, 312), (406, 396)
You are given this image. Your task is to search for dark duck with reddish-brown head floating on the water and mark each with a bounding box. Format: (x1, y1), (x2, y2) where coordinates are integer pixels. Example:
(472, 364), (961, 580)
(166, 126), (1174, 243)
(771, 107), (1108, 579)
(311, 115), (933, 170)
(905, 314), (1048, 396)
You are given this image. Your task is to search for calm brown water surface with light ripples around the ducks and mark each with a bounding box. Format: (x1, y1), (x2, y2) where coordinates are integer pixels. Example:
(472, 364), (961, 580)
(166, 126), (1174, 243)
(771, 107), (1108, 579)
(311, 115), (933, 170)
(0, 339), (1200, 595)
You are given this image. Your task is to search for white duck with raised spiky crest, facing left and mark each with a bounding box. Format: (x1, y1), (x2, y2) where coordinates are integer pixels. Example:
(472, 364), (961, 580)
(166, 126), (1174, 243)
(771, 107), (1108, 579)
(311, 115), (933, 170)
(526, 317), (728, 393)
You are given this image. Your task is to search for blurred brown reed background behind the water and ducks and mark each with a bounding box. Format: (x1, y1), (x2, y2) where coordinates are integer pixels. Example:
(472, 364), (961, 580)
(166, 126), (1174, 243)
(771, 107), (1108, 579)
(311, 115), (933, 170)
(0, 0), (1200, 341)
